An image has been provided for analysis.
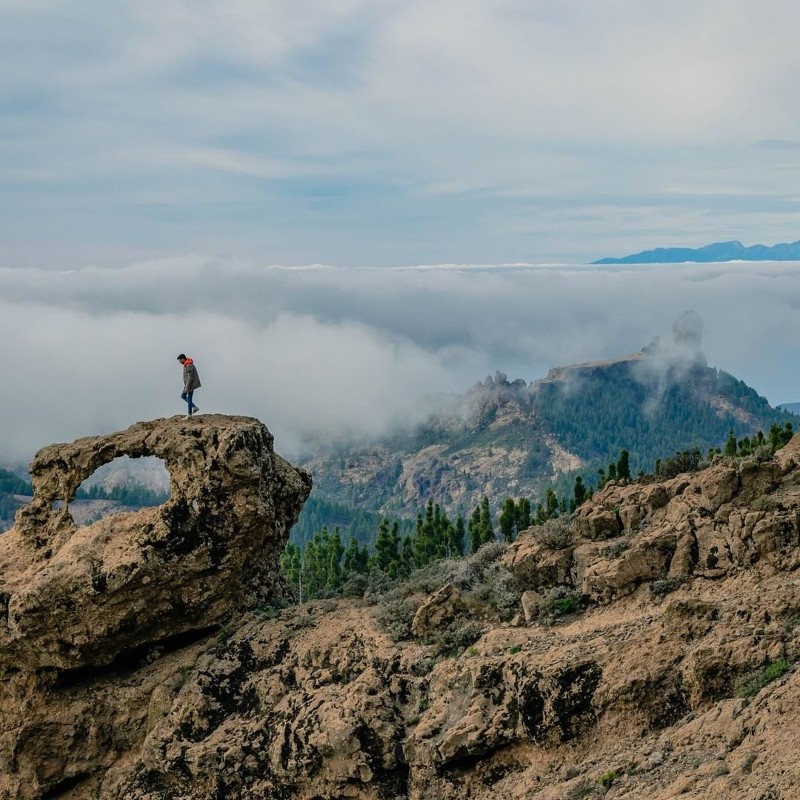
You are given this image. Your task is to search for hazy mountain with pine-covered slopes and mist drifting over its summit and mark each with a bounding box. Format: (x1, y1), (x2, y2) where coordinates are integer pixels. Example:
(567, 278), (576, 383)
(301, 341), (793, 518)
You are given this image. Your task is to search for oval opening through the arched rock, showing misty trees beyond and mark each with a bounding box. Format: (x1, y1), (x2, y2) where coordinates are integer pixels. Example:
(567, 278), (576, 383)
(69, 456), (169, 526)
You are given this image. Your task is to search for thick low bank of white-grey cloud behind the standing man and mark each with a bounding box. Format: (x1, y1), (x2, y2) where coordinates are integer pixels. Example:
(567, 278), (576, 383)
(0, 256), (800, 461)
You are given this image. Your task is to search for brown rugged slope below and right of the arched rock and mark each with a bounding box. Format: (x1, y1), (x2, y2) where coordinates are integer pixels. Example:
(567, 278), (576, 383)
(7, 434), (800, 800)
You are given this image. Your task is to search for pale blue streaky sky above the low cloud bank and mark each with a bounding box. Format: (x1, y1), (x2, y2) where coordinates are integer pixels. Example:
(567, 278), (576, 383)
(0, 0), (800, 268)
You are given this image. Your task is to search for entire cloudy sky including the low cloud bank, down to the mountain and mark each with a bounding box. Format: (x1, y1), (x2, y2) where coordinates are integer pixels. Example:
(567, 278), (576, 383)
(0, 0), (800, 461)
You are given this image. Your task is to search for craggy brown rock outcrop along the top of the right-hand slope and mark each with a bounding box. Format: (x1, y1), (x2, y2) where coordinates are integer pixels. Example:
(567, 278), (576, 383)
(506, 436), (800, 603)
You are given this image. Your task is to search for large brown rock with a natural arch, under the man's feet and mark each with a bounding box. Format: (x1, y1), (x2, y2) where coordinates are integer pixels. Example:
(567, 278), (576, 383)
(0, 415), (311, 670)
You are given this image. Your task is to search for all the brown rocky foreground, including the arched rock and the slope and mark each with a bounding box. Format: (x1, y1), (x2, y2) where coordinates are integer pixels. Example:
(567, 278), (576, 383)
(0, 417), (800, 800)
